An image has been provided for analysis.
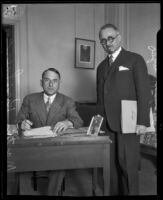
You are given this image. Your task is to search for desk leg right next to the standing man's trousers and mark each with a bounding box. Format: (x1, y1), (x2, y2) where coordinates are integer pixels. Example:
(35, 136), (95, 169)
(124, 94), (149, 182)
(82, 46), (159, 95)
(103, 145), (110, 196)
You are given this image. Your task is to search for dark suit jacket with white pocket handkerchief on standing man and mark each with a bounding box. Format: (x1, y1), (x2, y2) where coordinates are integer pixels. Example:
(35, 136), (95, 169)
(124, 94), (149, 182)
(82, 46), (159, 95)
(97, 48), (150, 131)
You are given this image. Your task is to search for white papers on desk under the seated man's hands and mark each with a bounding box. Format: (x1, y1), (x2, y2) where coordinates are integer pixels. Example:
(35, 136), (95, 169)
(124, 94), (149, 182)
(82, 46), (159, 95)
(23, 126), (57, 138)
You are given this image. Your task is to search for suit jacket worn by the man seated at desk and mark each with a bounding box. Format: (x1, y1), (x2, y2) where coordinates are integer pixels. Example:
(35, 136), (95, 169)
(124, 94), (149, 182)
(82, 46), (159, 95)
(17, 92), (83, 128)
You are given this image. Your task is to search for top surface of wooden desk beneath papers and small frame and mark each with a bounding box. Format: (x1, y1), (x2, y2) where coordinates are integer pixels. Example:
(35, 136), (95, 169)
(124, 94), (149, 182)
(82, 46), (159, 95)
(9, 133), (111, 148)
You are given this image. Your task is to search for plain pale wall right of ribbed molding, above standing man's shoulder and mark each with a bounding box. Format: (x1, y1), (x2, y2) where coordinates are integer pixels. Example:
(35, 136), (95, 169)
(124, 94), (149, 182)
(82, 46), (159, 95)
(128, 3), (160, 76)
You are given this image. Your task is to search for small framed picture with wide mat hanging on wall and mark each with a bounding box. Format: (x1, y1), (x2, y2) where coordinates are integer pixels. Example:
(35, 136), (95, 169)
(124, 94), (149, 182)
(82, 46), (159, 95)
(75, 38), (95, 69)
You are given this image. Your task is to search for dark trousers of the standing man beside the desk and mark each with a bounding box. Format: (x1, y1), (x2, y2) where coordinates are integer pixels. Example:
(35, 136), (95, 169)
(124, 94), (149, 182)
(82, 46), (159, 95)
(108, 130), (139, 195)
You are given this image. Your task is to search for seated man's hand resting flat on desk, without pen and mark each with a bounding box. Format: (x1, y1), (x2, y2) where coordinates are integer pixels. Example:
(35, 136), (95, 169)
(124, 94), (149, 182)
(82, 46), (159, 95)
(52, 120), (73, 135)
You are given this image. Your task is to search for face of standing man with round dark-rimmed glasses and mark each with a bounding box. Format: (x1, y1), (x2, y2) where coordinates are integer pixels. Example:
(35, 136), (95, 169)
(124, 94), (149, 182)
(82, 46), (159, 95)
(100, 28), (121, 54)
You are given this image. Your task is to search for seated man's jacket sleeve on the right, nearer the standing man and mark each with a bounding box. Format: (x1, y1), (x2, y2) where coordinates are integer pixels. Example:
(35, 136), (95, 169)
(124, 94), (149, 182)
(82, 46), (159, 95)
(67, 99), (83, 128)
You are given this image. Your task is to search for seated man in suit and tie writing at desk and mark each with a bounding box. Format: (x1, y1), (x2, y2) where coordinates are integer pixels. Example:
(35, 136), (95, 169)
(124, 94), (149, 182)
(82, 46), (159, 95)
(17, 68), (83, 196)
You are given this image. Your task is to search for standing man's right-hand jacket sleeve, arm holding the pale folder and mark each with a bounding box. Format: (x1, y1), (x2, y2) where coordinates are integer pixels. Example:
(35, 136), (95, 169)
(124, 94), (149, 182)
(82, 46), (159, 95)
(133, 56), (151, 127)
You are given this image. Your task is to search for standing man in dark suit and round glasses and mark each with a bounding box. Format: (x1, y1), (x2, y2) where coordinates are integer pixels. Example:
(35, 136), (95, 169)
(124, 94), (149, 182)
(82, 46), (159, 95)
(97, 24), (150, 195)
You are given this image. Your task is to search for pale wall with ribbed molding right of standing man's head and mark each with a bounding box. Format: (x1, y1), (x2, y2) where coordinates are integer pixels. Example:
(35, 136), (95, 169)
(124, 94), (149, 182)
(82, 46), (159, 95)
(105, 3), (160, 76)
